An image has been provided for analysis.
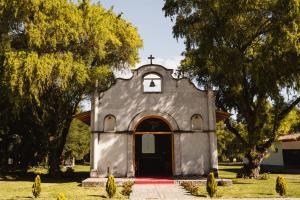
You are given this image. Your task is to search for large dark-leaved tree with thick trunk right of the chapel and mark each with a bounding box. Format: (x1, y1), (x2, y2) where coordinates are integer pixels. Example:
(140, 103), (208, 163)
(163, 0), (300, 177)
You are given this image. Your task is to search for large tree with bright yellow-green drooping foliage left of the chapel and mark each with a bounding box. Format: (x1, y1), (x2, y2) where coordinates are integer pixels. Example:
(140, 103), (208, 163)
(0, 0), (142, 175)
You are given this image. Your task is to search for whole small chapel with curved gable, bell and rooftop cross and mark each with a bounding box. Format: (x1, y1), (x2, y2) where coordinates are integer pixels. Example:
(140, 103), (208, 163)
(76, 60), (228, 177)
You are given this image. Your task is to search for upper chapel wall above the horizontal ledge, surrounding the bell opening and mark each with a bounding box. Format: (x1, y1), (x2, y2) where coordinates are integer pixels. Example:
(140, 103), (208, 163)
(94, 66), (208, 132)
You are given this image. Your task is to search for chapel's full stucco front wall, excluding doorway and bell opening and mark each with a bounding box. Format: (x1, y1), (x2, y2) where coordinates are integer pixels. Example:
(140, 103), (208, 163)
(91, 65), (218, 177)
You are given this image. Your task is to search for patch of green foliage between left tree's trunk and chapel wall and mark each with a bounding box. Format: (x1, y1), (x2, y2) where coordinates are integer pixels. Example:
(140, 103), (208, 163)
(63, 119), (90, 160)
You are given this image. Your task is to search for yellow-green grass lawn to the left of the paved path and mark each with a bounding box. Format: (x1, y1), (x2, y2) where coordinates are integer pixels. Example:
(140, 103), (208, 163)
(0, 166), (128, 200)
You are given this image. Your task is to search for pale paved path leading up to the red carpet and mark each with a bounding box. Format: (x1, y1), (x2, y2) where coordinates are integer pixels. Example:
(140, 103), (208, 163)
(130, 184), (198, 200)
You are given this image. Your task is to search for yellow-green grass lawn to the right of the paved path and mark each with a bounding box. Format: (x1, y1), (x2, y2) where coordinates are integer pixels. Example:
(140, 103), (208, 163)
(192, 165), (300, 198)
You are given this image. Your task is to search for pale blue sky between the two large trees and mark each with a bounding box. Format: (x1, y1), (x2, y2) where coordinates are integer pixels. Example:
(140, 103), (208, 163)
(96, 0), (184, 68)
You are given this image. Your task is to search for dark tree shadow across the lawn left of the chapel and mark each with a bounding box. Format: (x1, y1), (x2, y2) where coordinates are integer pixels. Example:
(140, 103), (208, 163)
(2, 171), (89, 186)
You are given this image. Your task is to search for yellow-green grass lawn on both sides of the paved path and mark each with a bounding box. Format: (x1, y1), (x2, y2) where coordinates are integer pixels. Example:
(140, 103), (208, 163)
(0, 165), (300, 200)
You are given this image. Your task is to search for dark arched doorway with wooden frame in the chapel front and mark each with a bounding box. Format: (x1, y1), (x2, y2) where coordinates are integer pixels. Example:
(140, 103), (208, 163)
(134, 118), (173, 176)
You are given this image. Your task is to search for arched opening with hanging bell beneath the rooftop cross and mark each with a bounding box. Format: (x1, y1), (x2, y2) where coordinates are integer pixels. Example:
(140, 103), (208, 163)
(143, 73), (162, 92)
